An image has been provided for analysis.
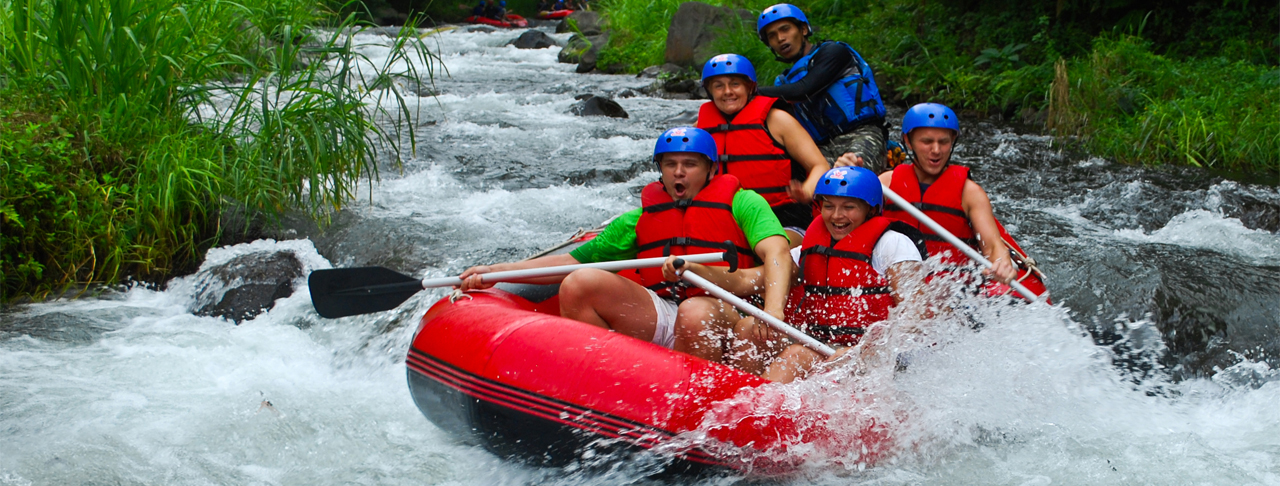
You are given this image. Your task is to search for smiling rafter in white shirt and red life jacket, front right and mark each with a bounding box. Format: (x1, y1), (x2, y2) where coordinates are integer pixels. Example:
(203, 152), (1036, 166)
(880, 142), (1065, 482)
(663, 168), (923, 382)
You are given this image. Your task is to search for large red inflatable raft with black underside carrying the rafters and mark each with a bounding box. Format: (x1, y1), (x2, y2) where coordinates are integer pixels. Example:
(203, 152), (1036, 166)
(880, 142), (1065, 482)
(406, 269), (890, 474)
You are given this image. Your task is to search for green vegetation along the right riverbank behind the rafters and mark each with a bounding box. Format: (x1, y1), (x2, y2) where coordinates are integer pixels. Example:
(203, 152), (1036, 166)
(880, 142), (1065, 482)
(598, 0), (1280, 176)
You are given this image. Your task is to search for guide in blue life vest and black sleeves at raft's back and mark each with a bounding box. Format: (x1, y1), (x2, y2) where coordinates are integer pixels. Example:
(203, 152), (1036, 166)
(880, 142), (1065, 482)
(755, 4), (888, 173)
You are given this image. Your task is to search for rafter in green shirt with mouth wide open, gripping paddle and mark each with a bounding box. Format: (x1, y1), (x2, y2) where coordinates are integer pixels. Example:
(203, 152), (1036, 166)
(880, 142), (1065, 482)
(461, 127), (791, 361)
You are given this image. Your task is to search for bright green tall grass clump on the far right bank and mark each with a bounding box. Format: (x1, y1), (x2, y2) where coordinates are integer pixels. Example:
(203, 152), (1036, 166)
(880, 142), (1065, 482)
(1059, 36), (1280, 173)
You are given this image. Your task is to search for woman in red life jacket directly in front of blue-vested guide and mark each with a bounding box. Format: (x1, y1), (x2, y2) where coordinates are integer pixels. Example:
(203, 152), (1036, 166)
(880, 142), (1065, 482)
(698, 54), (831, 247)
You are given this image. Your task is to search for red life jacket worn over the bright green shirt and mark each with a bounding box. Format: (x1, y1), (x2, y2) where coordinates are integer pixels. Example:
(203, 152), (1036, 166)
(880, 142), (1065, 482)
(636, 175), (756, 301)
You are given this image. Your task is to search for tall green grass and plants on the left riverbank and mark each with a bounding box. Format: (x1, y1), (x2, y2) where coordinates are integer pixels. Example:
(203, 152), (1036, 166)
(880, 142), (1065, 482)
(0, 0), (431, 302)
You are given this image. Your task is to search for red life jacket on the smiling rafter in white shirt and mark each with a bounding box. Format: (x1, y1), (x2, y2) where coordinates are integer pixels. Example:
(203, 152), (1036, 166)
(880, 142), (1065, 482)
(787, 216), (893, 345)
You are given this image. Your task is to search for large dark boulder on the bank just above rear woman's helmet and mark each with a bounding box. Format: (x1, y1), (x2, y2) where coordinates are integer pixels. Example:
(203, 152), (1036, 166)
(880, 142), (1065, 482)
(666, 1), (755, 69)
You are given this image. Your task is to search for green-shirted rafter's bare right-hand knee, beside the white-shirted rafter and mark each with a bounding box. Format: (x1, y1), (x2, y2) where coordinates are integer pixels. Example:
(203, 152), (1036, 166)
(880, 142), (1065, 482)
(675, 297), (741, 363)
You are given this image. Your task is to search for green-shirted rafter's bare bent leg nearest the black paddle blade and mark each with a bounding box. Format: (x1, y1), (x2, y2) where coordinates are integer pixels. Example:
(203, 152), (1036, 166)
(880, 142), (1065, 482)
(559, 269), (658, 341)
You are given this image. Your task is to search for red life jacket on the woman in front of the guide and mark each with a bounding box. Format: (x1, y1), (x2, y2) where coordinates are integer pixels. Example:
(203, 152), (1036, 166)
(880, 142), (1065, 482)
(698, 96), (795, 206)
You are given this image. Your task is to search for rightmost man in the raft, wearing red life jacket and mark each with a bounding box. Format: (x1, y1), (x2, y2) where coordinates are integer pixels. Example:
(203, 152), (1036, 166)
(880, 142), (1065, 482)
(879, 102), (1016, 283)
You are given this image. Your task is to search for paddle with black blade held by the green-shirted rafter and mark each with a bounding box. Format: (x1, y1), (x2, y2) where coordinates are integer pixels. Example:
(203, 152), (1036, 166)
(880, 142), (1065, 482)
(307, 252), (737, 318)
